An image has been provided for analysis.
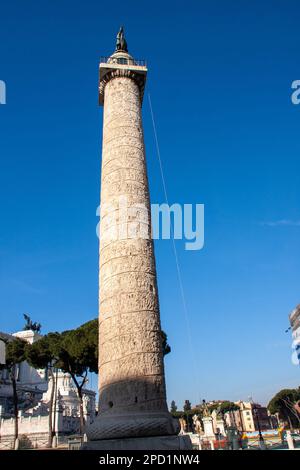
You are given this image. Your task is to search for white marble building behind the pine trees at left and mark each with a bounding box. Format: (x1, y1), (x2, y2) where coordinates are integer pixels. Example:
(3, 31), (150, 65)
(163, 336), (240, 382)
(0, 330), (96, 449)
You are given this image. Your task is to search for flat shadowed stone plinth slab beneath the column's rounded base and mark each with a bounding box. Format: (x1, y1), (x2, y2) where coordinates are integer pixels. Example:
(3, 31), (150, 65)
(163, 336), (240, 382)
(81, 436), (192, 450)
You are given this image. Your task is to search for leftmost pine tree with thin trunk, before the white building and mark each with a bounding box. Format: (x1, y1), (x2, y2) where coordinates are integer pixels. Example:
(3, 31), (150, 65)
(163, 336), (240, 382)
(1, 338), (26, 448)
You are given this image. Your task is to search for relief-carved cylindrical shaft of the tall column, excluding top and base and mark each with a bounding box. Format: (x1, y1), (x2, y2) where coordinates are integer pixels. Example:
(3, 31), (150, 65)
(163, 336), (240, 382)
(99, 70), (167, 418)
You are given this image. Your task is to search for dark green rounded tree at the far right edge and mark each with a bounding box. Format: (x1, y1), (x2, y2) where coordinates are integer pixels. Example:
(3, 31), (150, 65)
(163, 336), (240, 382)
(267, 388), (300, 428)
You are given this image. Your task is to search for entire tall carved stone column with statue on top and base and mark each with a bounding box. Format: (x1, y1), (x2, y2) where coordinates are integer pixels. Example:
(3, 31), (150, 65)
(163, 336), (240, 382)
(83, 28), (189, 450)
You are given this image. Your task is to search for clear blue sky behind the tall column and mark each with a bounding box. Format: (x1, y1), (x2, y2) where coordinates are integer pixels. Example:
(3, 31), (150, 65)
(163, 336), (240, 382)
(0, 0), (300, 406)
